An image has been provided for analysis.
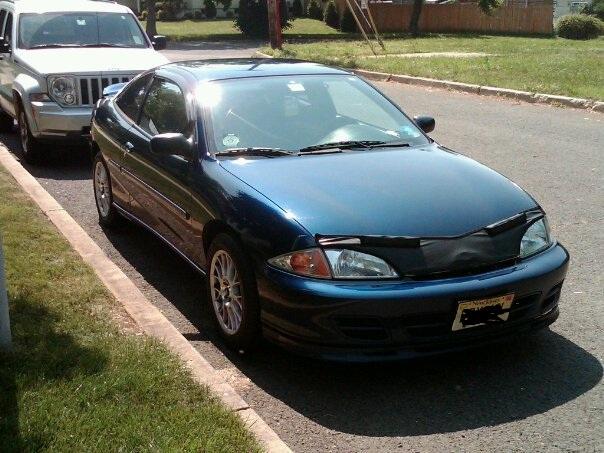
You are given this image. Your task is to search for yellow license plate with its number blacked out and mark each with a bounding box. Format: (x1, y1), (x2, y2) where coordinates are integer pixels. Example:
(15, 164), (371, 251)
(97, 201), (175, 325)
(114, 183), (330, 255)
(451, 294), (514, 331)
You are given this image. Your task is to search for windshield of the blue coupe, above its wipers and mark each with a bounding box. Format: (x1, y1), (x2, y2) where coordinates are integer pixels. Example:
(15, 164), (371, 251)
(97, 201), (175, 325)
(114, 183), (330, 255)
(203, 75), (429, 154)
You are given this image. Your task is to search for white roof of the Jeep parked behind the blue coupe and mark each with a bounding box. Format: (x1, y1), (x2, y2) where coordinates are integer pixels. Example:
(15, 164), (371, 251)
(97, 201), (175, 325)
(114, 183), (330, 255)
(2, 0), (130, 13)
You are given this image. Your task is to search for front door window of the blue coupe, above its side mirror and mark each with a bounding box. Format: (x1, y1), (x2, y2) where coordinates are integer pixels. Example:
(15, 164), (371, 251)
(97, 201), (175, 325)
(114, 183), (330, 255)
(139, 78), (188, 135)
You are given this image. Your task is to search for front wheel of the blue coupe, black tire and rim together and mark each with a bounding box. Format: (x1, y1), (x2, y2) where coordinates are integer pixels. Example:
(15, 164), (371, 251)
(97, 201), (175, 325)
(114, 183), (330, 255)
(207, 234), (260, 352)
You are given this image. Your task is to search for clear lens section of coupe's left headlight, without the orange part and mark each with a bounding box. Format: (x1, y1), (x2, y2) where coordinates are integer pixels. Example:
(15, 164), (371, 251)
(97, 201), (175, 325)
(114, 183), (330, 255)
(325, 249), (398, 279)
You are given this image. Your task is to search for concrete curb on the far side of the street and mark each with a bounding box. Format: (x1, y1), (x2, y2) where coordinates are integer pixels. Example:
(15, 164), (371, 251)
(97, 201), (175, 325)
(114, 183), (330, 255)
(255, 52), (604, 113)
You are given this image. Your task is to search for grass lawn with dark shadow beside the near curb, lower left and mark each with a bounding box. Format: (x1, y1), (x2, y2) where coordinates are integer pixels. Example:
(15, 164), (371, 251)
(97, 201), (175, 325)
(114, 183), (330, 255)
(0, 168), (260, 452)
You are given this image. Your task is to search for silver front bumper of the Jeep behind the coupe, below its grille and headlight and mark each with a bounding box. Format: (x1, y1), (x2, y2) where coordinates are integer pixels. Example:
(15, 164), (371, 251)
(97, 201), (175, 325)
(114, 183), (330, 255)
(29, 102), (92, 140)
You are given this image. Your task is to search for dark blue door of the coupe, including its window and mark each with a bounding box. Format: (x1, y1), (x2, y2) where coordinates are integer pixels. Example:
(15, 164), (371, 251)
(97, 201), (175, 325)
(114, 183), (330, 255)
(122, 76), (194, 256)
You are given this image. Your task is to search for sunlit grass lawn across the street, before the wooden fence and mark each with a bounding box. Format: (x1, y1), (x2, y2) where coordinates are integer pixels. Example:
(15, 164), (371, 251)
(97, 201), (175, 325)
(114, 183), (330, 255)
(263, 35), (604, 100)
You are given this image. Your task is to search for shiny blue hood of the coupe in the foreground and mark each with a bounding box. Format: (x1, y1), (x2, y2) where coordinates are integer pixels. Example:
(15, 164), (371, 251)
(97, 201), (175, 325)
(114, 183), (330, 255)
(221, 145), (537, 238)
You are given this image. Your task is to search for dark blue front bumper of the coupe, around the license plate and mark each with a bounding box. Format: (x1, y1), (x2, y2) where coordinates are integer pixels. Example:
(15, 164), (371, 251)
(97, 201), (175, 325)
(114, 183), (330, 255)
(258, 244), (569, 361)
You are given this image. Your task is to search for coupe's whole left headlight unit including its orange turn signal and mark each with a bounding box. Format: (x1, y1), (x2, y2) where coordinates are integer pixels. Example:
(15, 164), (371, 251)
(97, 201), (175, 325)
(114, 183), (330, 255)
(268, 248), (398, 279)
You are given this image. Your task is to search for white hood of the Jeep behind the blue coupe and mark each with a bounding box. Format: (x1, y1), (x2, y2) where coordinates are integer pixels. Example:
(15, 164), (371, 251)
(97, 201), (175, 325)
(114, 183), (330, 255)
(15, 48), (168, 75)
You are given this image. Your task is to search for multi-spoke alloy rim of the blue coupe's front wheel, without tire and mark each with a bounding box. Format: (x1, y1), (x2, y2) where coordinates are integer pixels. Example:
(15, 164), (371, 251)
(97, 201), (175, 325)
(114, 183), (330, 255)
(210, 250), (244, 335)
